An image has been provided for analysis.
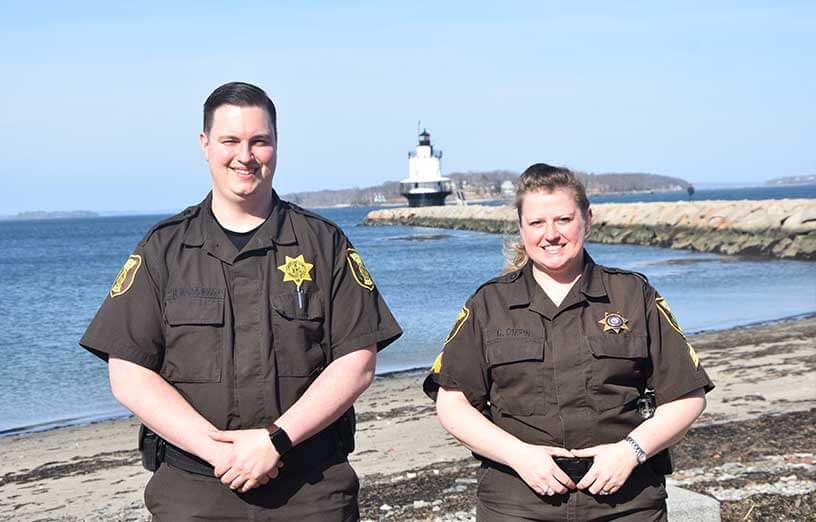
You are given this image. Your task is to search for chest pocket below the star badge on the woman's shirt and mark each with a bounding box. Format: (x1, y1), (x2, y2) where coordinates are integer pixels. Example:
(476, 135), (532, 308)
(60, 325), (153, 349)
(586, 334), (649, 410)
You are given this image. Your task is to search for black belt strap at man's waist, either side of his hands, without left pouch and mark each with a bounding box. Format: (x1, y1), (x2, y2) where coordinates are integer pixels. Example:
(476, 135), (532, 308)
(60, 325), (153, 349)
(159, 425), (346, 477)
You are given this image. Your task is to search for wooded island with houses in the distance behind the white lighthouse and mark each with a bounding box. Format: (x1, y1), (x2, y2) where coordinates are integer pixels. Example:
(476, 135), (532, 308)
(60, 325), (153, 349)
(283, 170), (689, 207)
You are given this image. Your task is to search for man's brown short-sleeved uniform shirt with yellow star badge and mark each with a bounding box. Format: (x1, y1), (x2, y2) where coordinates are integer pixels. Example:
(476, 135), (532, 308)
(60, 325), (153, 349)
(80, 191), (402, 429)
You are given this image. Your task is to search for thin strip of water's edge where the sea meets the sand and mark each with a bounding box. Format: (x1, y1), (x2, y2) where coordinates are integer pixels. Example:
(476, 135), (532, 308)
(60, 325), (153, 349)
(0, 310), (816, 440)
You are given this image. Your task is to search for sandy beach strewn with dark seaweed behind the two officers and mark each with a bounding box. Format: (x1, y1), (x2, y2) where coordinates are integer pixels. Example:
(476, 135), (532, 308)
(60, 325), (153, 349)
(0, 317), (816, 521)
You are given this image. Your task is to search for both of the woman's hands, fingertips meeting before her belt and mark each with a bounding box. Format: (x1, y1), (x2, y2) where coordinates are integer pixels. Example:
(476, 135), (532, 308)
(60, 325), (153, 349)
(509, 441), (638, 496)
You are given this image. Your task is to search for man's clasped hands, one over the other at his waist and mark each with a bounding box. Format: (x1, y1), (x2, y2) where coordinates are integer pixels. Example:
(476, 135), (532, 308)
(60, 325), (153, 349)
(207, 428), (283, 493)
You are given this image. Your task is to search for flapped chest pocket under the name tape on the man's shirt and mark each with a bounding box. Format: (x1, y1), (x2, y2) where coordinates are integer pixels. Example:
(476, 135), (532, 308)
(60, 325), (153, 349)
(161, 297), (224, 382)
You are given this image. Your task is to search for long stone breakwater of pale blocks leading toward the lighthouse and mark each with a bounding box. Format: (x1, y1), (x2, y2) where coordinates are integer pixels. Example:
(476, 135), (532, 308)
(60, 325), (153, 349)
(363, 199), (816, 260)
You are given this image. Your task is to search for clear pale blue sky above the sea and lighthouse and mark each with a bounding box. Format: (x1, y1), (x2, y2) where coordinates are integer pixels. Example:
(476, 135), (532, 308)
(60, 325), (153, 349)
(0, 1), (816, 215)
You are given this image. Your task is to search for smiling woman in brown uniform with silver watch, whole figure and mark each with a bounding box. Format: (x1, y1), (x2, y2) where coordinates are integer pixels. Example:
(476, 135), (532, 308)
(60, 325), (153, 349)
(425, 164), (713, 521)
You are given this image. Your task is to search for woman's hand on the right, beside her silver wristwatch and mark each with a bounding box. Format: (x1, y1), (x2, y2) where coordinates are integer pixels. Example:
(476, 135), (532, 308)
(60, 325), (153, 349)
(572, 441), (638, 495)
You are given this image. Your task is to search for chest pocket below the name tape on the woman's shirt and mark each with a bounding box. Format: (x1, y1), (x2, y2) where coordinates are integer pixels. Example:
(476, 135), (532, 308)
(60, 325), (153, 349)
(486, 337), (556, 415)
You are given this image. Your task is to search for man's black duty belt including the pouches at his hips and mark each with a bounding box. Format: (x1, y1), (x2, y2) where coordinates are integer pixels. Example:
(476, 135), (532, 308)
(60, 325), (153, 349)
(139, 425), (346, 477)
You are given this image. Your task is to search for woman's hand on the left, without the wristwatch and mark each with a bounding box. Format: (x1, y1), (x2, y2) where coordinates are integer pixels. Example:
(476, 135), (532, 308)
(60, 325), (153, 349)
(508, 442), (576, 496)
